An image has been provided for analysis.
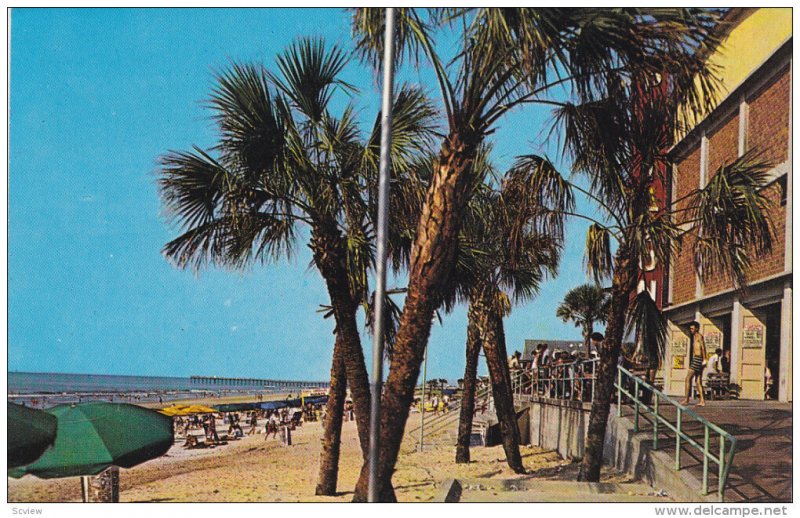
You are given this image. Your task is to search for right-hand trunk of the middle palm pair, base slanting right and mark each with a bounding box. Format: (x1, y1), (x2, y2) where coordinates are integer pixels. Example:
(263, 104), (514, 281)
(478, 291), (525, 473)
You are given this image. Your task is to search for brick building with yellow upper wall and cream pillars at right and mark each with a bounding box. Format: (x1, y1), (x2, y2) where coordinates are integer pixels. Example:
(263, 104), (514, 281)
(664, 8), (792, 401)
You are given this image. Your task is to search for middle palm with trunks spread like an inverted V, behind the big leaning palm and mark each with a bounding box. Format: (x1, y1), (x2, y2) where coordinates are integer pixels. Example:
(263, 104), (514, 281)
(452, 161), (561, 473)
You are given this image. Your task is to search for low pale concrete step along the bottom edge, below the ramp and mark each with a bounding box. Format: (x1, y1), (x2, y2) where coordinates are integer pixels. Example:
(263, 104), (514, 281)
(437, 478), (673, 503)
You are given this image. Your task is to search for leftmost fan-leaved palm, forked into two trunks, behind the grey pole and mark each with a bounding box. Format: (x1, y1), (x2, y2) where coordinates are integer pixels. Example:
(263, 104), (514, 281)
(153, 39), (433, 494)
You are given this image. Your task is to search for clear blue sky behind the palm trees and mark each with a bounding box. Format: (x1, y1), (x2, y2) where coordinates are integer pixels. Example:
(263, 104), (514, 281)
(8, 9), (593, 380)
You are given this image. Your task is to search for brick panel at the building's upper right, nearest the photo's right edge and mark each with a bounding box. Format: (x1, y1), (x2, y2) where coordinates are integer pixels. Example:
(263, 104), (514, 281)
(747, 68), (791, 165)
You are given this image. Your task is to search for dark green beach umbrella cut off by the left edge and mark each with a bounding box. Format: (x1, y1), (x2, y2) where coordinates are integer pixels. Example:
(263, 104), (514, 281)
(8, 403), (56, 468)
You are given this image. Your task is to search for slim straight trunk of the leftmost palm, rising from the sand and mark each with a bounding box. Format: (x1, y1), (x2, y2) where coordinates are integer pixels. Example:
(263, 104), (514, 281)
(315, 336), (347, 496)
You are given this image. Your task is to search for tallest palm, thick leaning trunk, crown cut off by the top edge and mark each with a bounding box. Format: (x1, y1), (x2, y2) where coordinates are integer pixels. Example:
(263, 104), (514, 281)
(353, 8), (716, 501)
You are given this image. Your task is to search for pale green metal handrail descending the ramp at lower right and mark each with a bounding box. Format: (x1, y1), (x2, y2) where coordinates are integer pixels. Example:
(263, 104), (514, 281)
(614, 367), (736, 501)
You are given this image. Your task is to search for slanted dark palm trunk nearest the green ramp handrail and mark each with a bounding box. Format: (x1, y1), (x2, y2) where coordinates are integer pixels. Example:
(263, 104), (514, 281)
(578, 252), (636, 482)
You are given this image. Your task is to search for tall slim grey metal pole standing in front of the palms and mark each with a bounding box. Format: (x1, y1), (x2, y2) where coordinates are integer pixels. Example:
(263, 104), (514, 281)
(367, 7), (394, 502)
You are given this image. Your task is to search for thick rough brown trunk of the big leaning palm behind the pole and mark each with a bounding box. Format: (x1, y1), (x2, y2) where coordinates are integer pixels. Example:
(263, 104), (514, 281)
(353, 133), (477, 502)
